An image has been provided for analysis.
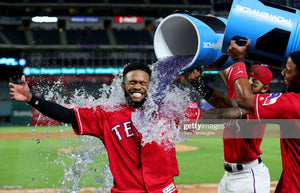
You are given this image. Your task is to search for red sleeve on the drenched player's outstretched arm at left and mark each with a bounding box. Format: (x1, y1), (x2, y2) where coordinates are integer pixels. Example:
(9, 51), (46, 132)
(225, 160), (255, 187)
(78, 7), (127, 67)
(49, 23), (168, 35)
(73, 107), (106, 140)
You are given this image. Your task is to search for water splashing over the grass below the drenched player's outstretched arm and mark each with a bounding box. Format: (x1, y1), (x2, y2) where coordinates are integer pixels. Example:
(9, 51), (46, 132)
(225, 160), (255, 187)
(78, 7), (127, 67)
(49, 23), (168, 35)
(53, 136), (113, 192)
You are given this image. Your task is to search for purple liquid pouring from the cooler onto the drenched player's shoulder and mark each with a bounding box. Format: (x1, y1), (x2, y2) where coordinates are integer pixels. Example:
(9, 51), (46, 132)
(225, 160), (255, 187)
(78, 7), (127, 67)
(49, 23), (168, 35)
(132, 56), (192, 148)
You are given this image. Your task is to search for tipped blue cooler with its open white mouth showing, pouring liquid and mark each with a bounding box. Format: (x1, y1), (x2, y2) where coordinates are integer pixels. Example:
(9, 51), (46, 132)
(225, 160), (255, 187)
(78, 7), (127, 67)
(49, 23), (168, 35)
(154, 13), (232, 70)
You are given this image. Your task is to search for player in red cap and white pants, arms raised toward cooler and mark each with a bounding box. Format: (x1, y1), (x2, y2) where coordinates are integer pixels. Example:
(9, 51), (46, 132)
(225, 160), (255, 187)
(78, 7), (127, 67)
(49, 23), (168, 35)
(184, 64), (273, 193)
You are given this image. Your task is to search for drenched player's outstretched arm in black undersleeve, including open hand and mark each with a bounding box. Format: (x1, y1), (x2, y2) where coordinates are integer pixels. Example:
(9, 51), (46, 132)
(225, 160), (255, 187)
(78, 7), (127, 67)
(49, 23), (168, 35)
(9, 75), (78, 128)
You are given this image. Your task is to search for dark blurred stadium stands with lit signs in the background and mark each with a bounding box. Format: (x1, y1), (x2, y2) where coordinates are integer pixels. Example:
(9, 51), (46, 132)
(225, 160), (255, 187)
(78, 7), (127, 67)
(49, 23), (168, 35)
(0, 0), (300, 125)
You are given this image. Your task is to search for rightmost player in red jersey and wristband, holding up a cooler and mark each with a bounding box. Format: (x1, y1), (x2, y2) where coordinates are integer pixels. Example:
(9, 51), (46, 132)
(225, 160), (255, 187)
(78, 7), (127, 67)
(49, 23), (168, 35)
(227, 40), (300, 193)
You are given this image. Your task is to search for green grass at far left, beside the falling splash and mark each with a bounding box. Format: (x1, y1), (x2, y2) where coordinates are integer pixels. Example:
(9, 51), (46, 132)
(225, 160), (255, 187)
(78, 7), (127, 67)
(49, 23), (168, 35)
(0, 139), (63, 188)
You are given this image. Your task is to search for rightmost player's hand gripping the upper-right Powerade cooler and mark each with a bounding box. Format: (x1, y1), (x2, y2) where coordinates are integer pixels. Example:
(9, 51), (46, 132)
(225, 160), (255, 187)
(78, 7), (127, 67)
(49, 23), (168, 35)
(227, 40), (250, 60)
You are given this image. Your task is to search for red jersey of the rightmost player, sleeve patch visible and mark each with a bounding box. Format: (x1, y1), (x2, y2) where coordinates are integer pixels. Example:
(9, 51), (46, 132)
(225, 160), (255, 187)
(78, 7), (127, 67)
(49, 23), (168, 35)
(254, 93), (300, 193)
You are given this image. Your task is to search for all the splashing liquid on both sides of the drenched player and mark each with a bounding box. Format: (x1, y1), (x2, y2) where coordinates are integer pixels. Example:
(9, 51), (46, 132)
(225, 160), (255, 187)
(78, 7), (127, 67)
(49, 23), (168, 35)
(31, 56), (192, 192)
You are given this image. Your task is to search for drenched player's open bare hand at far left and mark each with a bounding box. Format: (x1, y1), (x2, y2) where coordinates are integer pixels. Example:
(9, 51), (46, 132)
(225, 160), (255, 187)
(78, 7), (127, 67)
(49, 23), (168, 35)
(9, 75), (32, 102)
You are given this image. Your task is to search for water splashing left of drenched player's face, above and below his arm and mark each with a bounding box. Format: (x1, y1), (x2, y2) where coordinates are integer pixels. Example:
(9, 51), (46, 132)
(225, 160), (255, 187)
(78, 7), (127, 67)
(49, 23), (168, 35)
(49, 76), (125, 192)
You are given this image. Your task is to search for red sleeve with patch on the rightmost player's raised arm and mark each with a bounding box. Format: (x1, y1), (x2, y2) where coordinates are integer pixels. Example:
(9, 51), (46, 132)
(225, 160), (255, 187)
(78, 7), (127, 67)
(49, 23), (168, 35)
(254, 93), (294, 119)
